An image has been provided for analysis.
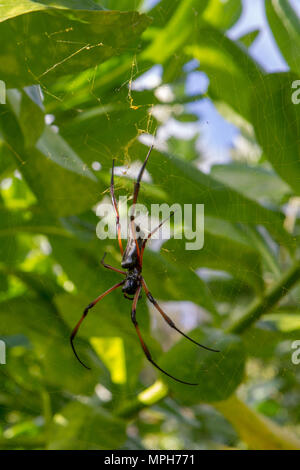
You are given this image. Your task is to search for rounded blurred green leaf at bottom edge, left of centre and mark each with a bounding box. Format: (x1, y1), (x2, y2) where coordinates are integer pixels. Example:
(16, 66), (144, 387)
(48, 402), (126, 450)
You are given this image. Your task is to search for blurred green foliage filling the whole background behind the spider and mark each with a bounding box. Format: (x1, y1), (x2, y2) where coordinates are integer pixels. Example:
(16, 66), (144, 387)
(0, 0), (300, 449)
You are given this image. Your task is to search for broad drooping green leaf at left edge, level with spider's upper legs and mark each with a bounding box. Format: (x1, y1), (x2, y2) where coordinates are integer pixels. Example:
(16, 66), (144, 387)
(0, 103), (99, 217)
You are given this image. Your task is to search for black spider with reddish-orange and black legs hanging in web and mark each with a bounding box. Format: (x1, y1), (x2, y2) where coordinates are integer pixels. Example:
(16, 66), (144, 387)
(70, 145), (219, 385)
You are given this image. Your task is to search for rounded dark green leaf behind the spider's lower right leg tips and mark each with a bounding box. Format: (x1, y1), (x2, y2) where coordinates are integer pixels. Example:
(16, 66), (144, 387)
(159, 329), (246, 405)
